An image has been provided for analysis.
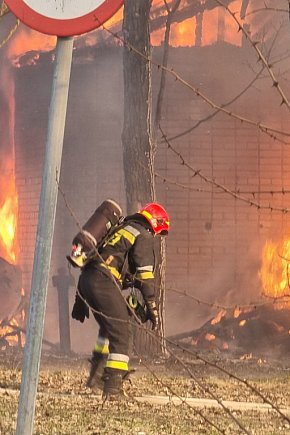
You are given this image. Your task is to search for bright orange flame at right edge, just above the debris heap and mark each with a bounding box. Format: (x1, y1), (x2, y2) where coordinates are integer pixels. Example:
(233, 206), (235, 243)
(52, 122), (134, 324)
(259, 238), (290, 298)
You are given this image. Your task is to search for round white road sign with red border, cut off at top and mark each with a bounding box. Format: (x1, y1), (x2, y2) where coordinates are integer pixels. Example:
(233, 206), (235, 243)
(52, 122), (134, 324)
(5, 0), (124, 36)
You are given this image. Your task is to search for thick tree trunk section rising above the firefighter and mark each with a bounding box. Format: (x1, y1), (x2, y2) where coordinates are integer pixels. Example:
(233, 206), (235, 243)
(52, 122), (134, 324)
(122, 0), (154, 214)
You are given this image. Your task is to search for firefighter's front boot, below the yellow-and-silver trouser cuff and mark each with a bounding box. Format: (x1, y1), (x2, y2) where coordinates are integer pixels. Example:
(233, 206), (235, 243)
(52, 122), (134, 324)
(102, 367), (128, 401)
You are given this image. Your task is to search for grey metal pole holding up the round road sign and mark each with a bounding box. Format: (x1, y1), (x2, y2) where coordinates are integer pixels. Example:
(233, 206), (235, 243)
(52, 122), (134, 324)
(16, 37), (73, 435)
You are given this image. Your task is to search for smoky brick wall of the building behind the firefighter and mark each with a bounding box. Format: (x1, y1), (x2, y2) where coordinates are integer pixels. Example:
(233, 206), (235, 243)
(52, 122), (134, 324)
(16, 45), (290, 350)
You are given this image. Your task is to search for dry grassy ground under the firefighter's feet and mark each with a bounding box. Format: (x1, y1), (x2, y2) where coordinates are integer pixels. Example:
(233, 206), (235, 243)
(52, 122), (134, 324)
(0, 349), (290, 435)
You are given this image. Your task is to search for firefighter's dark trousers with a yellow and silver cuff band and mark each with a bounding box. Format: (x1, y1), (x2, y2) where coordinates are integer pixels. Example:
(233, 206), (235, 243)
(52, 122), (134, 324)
(78, 267), (130, 371)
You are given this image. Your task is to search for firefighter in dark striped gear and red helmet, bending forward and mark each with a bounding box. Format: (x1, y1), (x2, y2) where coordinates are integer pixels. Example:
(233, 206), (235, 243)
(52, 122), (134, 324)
(72, 203), (169, 400)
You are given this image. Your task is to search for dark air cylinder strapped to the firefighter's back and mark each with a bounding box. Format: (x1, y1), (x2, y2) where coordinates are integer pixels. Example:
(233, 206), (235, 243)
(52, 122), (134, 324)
(67, 199), (123, 267)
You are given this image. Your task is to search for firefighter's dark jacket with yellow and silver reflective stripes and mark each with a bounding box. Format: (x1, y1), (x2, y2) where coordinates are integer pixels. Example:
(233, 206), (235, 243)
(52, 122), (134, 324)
(85, 214), (155, 301)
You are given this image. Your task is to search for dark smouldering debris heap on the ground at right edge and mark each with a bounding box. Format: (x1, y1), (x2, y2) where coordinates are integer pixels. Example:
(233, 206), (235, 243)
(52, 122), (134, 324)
(176, 305), (290, 357)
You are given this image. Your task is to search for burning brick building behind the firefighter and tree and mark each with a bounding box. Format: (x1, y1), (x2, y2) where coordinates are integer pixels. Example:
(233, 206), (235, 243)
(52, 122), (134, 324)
(0, 1), (290, 350)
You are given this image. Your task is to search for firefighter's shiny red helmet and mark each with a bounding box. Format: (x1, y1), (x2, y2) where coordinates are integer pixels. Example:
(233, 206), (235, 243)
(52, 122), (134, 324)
(138, 202), (170, 236)
